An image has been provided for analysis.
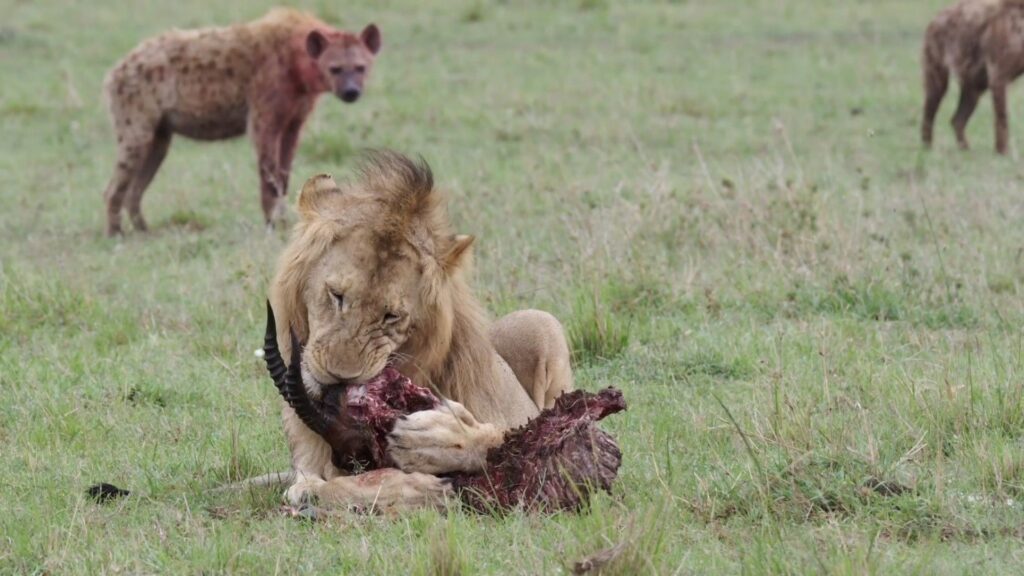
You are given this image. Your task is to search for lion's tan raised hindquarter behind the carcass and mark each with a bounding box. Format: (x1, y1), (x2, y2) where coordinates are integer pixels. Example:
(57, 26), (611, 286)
(489, 310), (572, 410)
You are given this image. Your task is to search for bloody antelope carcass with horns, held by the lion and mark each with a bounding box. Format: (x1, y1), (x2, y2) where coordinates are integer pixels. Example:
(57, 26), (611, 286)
(264, 303), (626, 511)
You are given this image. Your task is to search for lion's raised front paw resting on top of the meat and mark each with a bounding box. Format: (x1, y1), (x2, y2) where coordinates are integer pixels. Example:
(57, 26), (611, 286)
(388, 402), (502, 475)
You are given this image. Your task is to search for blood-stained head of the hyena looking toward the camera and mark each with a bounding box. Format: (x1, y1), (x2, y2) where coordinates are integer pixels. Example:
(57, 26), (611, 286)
(306, 24), (381, 102)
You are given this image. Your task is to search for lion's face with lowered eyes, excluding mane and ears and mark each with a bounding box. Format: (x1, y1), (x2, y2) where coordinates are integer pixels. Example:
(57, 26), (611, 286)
(303, 227), (426, 384)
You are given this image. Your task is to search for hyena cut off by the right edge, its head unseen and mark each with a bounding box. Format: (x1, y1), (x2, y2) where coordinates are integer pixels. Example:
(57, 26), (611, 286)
(921, 0), (1024, 154)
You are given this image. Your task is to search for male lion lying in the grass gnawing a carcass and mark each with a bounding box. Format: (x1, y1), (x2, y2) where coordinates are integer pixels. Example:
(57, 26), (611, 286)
(270, 152), (572, 508)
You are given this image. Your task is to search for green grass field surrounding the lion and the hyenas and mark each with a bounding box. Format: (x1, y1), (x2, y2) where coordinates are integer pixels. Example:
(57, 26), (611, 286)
(0, 0), (1024, 574)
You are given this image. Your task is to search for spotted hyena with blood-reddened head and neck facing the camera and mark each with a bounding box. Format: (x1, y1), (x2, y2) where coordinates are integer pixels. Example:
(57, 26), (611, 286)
(103, 9), (381, 235)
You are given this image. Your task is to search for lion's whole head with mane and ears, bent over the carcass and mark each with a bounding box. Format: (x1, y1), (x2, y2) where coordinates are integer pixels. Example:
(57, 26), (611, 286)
(271, 152), (485, 393)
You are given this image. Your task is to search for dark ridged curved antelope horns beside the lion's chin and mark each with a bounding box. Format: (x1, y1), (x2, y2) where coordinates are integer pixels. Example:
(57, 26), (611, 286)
(263, 300), (329, 436)
